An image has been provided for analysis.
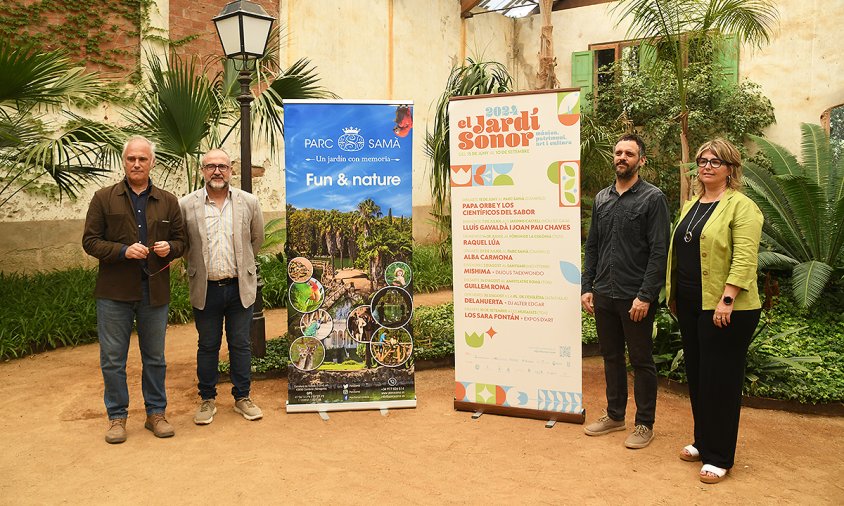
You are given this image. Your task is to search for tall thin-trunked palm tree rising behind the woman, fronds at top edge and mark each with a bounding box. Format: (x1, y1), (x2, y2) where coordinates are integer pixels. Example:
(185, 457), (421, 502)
(613, 0), (778, 206)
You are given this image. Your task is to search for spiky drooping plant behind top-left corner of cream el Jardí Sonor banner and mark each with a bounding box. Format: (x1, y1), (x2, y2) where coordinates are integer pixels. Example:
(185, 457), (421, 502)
(425, 58), (513, 228)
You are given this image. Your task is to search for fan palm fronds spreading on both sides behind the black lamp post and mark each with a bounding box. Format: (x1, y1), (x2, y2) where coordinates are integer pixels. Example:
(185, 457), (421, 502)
(126, 36), (334, 191)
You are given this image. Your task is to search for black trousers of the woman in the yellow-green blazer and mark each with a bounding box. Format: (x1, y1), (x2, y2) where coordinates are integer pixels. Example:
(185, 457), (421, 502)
(677, 293), (762, 469)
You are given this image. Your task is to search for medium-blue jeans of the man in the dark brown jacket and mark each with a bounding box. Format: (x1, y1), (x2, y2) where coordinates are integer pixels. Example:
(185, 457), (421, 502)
(97, 283), (168, 419)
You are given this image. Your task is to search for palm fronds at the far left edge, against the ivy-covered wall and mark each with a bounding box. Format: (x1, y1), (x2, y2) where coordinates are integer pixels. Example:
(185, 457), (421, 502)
(0, 38), (119, 207)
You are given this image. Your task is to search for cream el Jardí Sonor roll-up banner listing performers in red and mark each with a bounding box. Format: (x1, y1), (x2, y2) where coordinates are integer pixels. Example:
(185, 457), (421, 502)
(449, 90), (584, 423)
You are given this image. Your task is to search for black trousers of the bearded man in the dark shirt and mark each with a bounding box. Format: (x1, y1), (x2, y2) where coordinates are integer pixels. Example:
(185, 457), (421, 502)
(593, 294), (656, 429)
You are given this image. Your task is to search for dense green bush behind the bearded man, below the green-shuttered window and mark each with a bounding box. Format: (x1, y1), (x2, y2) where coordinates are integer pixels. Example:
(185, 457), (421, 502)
(592, 50), (774, 209)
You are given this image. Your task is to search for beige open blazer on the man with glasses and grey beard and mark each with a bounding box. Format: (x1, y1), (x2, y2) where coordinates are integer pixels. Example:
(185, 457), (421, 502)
(179, 188), (264, 309)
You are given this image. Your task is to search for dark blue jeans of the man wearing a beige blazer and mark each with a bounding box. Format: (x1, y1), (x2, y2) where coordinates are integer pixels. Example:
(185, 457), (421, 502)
(193, 282), (252, 399)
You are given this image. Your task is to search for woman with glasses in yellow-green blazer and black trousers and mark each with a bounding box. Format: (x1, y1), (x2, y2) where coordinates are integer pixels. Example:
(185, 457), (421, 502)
(665, 139), (763, 483)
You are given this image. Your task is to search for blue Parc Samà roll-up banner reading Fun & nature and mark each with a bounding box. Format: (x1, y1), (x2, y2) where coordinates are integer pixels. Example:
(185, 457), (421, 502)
(284, 100), (416, 412)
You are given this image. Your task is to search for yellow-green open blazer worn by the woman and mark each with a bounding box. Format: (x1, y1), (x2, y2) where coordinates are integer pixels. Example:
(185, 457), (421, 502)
(665, 189), (764, 311)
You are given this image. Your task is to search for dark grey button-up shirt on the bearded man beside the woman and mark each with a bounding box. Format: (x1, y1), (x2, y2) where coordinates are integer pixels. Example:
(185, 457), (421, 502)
(581, 177), (670, 302)
